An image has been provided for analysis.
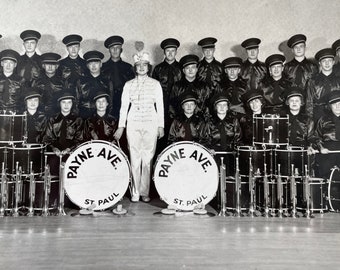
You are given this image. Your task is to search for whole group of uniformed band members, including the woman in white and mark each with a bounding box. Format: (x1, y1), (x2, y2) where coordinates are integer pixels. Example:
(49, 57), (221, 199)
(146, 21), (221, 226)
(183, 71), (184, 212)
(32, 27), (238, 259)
(0, 30), (340, 206)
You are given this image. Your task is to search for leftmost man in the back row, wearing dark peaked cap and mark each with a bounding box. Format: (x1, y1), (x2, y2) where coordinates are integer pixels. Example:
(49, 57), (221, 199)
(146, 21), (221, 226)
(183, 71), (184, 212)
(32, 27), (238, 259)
(17, 30), (42, 87)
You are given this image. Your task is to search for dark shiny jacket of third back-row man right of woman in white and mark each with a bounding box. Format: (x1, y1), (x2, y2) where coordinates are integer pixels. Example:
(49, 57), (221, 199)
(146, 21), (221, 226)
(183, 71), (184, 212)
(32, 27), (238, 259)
(240, 59), (267, 90)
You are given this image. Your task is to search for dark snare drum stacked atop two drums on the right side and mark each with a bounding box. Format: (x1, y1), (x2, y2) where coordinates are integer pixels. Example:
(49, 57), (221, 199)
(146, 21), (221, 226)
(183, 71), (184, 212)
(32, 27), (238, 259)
(253, 114), (289, 147)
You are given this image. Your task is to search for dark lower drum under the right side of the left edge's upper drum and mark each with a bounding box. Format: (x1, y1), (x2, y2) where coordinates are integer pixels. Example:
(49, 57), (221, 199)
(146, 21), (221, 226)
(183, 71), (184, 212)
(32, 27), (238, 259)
(7, 144), (45, 176)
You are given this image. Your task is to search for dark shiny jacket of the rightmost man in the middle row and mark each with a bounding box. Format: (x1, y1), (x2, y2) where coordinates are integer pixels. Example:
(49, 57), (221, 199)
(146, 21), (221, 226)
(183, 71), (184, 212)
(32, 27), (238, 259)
(306, 72), (340, 122)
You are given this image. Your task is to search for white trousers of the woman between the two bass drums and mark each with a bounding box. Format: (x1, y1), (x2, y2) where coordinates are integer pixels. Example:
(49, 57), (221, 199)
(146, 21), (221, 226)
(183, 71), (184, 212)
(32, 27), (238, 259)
(126, 121), (158, 196)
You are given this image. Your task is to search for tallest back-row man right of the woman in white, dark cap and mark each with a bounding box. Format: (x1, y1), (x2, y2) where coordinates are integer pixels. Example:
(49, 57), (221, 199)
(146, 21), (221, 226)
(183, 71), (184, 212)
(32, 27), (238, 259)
(284, 34), (318, 91)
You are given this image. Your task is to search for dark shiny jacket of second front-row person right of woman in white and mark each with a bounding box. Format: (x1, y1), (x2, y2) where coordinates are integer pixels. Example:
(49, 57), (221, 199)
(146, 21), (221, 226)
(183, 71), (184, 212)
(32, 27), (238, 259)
(200, 112), (242, 151)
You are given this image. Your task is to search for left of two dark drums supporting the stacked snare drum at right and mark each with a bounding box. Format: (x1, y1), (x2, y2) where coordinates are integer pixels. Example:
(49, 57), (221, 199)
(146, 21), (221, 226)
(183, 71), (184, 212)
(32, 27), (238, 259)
(238, 146), (273, 176)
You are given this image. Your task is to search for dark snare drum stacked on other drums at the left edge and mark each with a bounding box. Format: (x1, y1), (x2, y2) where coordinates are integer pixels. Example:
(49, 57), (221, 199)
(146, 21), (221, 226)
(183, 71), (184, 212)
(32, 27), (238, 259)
(0, 112), (27, 143)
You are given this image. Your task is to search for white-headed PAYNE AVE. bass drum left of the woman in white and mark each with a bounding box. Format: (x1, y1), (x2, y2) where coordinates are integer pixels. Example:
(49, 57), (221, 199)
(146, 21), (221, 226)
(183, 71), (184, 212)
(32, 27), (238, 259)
(63, 140), (131, 210)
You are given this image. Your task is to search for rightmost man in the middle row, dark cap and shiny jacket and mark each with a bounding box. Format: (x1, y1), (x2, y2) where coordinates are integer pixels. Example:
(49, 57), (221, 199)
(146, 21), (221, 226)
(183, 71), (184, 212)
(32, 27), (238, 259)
(306, 48), (340, 122)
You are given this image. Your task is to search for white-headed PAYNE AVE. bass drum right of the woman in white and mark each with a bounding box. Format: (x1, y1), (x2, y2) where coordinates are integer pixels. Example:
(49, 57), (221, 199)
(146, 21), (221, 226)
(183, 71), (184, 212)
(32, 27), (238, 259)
(153, 142), (218, 211)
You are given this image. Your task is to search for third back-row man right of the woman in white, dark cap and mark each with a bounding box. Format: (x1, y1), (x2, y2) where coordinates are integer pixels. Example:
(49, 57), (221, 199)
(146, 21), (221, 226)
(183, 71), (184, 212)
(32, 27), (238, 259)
(241, 38), (267, 90)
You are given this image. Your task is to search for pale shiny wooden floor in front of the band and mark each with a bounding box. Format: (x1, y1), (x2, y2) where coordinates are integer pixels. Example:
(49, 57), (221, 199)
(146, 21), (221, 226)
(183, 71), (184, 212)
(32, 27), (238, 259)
(0, 198), (340, 270)
